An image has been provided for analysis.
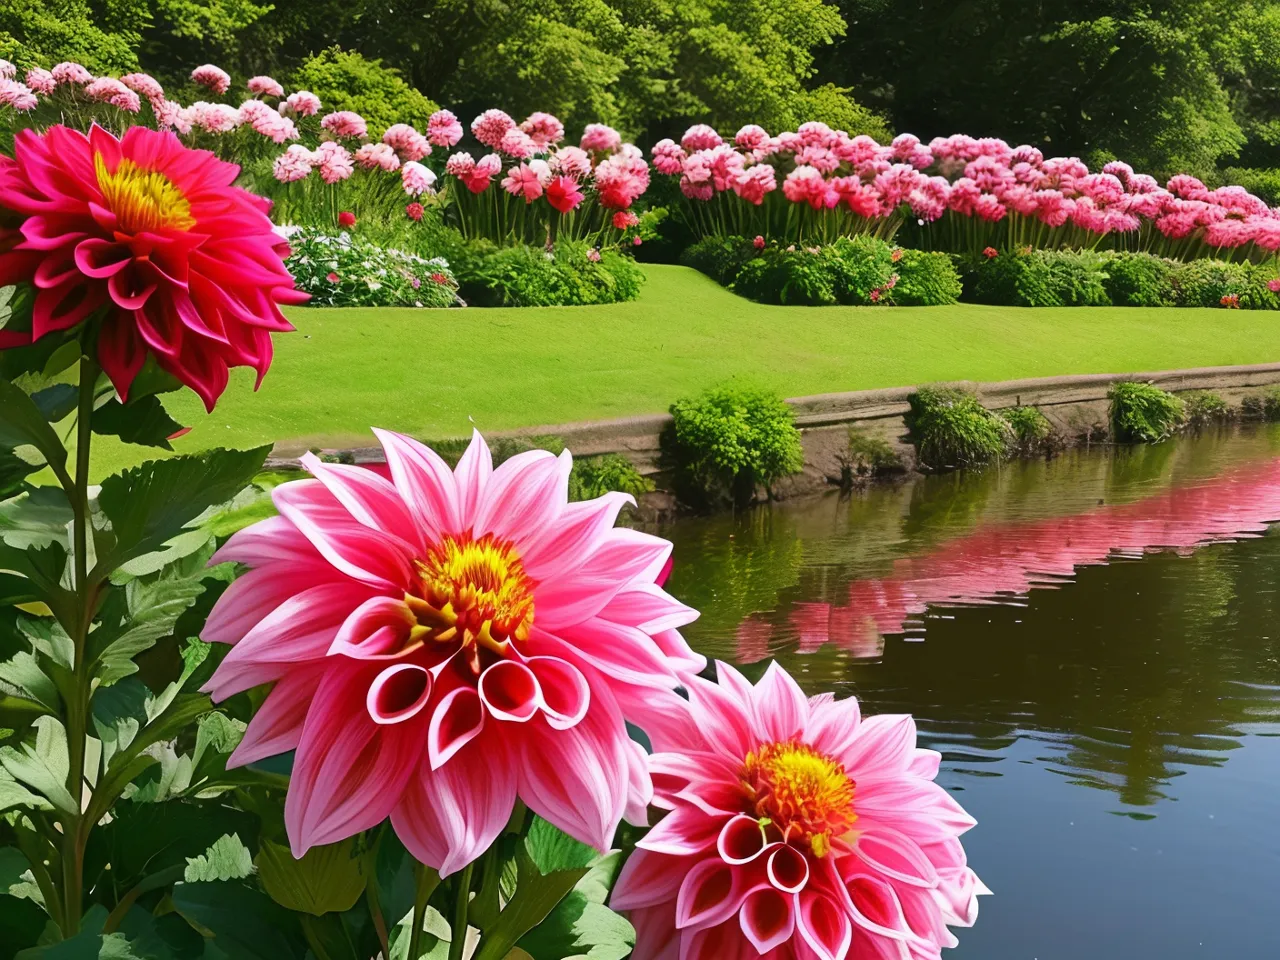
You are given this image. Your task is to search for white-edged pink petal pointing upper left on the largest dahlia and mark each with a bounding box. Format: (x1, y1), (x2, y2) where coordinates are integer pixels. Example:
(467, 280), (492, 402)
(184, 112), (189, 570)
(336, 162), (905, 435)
(271, 480), (413, 593)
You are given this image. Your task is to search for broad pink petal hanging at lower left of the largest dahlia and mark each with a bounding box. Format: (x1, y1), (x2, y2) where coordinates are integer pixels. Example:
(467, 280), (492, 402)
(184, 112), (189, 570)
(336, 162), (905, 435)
(282, 650), (426, 856)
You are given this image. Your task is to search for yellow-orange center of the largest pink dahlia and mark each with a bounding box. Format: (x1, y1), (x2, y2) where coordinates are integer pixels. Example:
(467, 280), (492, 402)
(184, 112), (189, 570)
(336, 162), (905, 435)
(404, 534), (534, 673)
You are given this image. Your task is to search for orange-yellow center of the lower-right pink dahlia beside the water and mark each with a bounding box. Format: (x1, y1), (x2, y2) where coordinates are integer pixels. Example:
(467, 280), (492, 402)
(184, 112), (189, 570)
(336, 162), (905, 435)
(742, 740), (858, 856)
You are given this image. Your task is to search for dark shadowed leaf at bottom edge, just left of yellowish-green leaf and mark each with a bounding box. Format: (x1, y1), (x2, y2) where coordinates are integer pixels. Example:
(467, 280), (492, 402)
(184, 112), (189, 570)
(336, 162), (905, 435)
(173, 882), (306, 960)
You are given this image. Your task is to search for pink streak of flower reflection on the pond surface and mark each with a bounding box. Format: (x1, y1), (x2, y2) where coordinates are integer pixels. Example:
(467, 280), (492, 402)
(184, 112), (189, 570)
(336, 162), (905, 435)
(739, 460), (1280, 663)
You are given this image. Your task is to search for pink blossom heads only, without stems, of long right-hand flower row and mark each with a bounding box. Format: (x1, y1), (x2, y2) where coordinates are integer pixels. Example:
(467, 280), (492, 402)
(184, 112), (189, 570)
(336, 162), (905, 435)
(653, 122), (1280, 252)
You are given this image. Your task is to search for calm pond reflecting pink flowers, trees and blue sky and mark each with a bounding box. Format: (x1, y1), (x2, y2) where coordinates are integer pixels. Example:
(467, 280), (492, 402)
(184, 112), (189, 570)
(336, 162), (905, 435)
(662, 428), (1280, 960)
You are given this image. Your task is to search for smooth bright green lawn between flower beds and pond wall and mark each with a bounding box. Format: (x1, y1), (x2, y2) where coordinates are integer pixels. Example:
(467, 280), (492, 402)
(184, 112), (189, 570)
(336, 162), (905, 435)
(95, 266), (1280, 474)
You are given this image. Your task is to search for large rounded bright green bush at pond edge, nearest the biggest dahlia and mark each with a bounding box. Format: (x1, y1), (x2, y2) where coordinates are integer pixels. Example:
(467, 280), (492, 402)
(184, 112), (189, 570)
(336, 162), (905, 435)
(668, 383), (804, 506)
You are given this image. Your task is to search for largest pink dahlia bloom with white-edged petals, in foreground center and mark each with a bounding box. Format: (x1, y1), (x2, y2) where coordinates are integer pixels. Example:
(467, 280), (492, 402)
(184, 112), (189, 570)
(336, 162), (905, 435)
(204, 431), (703, 874)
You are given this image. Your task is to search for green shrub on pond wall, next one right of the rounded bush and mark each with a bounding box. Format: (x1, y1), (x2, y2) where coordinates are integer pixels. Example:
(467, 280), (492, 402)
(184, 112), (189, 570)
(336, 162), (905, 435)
(908, 387), (1012, 470)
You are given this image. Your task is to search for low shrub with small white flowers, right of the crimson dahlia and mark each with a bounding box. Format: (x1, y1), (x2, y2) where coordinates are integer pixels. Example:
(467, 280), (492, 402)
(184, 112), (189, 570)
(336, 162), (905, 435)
(287, 228), (461, 307)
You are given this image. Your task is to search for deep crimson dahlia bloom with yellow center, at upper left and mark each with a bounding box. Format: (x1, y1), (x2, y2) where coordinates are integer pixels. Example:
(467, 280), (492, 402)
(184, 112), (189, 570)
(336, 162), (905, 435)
(0, 124), (307, 410)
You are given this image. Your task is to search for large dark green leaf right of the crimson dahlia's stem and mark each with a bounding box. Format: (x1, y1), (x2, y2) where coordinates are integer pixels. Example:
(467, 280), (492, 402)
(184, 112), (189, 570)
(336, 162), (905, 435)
(97, 447), (271, 571)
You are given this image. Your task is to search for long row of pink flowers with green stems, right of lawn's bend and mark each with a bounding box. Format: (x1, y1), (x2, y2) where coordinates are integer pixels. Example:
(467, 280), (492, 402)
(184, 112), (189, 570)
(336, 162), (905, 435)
(653, 122), (1280, 260)
